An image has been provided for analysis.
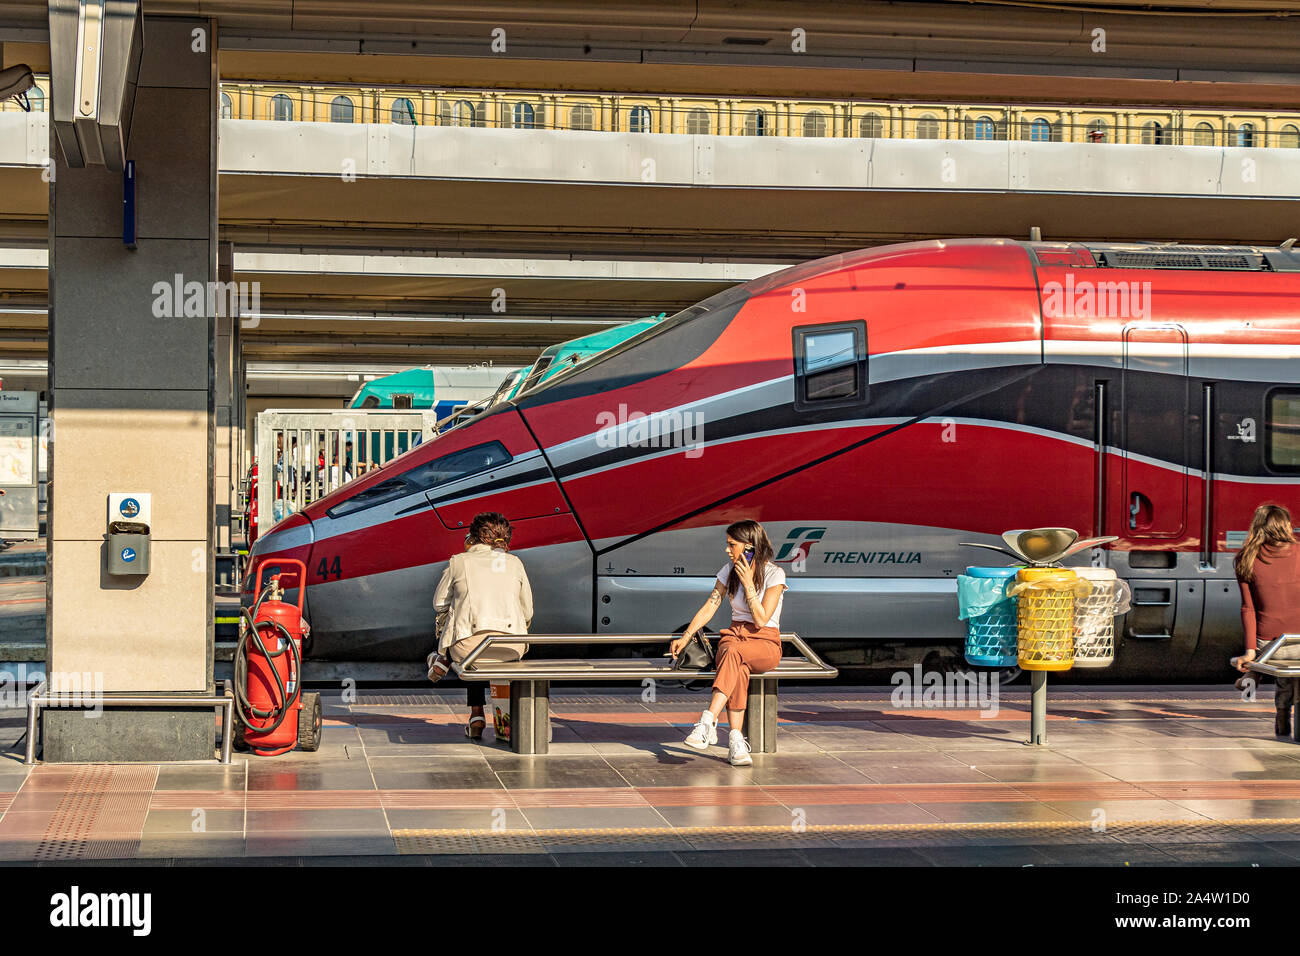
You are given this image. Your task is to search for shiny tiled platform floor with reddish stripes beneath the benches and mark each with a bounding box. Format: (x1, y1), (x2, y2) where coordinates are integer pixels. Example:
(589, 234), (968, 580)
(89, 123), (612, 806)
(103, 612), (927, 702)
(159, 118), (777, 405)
(0, 687), (1300, 866)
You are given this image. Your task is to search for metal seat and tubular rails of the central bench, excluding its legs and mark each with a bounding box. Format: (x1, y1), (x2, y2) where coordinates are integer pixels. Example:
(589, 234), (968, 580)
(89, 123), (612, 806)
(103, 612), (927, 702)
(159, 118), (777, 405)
(455, 631), (840, 680)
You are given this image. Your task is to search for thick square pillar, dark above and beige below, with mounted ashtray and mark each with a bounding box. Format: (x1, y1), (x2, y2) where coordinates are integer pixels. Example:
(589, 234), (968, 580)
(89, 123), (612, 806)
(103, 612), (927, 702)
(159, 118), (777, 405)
(43, 17), (217, 762)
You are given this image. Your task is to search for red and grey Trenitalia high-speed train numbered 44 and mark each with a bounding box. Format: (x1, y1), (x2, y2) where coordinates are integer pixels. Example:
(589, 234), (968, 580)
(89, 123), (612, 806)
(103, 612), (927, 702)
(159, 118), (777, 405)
(244, 239), (1300, 679)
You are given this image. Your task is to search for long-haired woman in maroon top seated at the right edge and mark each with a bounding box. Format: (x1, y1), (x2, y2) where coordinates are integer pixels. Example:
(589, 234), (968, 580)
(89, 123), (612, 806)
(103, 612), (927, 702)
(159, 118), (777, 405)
(1232, 505), (1300, 736)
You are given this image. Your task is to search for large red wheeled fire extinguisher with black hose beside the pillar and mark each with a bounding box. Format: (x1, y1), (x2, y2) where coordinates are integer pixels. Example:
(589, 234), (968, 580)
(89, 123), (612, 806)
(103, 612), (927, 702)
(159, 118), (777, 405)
(233, 558), (321, 757)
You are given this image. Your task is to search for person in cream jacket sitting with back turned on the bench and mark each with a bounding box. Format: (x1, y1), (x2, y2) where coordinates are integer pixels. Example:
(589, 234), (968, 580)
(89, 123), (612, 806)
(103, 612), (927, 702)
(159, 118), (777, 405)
(429, 511), (533, 740)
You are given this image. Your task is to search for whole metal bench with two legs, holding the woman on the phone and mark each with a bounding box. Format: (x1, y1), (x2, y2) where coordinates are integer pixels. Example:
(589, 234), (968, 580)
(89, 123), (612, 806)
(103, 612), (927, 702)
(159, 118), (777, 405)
(452, 632), (839, 754)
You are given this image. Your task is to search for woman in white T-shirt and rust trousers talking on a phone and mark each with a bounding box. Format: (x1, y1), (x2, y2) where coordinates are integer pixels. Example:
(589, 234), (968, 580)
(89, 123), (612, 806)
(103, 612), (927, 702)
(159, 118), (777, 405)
(668, 520), (785, 766)
